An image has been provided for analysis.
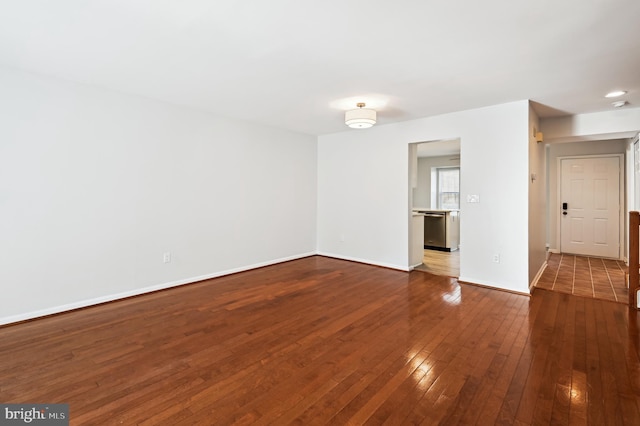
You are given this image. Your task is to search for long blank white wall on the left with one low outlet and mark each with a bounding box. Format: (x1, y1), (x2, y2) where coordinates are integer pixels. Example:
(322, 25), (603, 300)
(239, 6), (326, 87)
(0, 69), (317, 323)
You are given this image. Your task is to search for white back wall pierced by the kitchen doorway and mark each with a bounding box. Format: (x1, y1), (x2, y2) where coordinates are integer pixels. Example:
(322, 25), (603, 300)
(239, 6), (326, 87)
(318, 101), (529, 293)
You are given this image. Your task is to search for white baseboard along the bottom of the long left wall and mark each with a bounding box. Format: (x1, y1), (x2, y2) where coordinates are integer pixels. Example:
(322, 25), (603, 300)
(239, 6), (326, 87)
(0, 252), (317, 325)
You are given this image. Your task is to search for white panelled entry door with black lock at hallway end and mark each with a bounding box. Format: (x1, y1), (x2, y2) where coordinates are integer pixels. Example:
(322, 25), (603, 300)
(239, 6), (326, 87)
(560, 157), (620, 259)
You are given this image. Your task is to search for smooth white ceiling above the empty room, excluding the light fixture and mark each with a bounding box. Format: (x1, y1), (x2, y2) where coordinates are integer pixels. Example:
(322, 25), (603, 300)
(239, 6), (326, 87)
(0, 0), (640, 135)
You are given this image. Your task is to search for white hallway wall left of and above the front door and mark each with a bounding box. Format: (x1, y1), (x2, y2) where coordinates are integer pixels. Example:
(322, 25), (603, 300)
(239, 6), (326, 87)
(547, 140), (627, 251)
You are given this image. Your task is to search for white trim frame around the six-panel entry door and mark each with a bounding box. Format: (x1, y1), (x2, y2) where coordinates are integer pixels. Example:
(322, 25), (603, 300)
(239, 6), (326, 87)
(549, 154), (627, 260)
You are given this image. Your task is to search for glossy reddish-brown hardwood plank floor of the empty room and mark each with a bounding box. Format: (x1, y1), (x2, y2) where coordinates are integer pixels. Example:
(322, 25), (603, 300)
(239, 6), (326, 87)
(0, 256), (640, 425)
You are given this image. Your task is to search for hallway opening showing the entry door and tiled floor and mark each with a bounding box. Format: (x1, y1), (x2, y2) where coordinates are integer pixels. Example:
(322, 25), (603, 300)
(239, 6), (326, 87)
(535, 138), (635, 302)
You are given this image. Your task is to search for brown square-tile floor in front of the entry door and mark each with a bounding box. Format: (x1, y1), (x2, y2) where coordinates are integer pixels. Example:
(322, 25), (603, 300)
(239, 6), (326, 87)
(536, 254), (629, 303)
